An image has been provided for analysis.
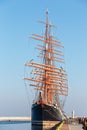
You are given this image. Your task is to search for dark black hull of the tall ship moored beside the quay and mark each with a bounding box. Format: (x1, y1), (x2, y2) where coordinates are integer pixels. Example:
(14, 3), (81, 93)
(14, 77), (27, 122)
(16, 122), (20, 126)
(32, 104), (63, 122)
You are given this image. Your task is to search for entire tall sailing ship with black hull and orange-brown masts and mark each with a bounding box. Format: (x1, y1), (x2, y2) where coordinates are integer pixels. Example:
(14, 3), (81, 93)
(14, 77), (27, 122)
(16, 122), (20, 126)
(25, 11), (68, 122)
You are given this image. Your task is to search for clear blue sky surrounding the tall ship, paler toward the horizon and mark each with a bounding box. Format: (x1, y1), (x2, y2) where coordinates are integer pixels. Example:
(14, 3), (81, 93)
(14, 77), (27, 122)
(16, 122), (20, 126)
(0, 0), (87, 116)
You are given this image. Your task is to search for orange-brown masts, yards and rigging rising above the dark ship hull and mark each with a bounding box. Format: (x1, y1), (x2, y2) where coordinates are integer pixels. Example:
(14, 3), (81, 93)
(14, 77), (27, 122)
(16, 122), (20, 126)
(25, 10), (68, 104)
